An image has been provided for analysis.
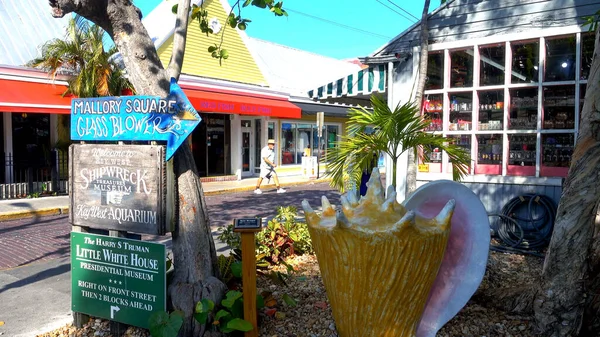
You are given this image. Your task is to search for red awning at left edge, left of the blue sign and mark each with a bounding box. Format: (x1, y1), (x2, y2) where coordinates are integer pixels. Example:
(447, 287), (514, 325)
(0, 79), (71, 114)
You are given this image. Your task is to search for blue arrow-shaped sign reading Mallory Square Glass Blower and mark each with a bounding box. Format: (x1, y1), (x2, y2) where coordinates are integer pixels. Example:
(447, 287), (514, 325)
(71, 79), (202, 160)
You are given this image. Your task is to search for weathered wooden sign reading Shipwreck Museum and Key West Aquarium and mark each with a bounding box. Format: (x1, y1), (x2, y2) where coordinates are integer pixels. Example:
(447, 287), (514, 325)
(69, 144), (166, 235)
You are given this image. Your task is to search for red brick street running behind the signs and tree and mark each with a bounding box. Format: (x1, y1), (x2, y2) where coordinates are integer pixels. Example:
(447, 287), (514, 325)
(0, 183), (339, 270)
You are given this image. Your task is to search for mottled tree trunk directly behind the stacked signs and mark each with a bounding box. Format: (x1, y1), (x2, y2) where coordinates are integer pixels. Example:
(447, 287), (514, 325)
(50, 0), (226, 336)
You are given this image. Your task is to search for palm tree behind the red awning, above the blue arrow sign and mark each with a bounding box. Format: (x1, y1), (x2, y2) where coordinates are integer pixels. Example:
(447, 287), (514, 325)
(27, 16), (133, 97)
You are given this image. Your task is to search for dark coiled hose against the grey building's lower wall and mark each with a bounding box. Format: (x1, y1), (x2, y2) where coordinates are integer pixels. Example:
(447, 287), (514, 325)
(490, 194), (556, 255)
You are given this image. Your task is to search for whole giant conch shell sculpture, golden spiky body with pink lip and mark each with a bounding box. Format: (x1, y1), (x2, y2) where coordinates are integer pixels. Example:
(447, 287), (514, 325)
(302, 169), (489, 337)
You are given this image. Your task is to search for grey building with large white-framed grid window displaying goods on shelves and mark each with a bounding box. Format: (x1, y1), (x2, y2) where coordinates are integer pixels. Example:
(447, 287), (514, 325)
(364, 0), (600, 213)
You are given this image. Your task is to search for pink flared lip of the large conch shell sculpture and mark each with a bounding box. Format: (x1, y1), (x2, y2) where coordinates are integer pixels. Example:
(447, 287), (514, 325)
(403, 180), (490, 337)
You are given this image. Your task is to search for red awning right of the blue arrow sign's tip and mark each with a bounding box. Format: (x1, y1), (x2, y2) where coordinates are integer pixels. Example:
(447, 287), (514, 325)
(182, 86), (302, 118)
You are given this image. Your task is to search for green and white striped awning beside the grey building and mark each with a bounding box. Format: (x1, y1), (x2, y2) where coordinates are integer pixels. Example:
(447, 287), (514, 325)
(308, 64), (386, 98)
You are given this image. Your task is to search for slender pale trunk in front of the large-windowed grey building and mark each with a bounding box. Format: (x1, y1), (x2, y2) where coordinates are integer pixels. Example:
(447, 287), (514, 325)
(405, 0), (429, 198)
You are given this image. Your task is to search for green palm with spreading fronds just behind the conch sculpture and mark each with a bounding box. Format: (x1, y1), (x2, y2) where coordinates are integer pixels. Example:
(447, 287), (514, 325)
(325, 95), (471, 191)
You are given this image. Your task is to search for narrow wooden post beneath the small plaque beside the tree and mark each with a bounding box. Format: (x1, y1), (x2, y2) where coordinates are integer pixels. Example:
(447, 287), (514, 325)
(241, 232), (258, 337)
